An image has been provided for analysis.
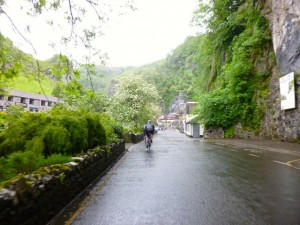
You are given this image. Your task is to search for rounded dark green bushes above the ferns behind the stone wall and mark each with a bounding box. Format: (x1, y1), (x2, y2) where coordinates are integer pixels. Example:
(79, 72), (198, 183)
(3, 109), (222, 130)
(0, 106), (111, 156)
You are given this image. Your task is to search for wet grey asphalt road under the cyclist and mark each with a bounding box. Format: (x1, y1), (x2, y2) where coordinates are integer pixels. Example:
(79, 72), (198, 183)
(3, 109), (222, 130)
(53, 130), (300, 225)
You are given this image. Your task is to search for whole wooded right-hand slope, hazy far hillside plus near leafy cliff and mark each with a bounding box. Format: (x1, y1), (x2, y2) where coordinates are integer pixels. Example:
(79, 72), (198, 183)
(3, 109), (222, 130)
(114, 0), (276, 133)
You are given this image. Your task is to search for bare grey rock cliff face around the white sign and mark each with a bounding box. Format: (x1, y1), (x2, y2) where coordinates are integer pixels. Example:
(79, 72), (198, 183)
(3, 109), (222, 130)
(260, 0), (300, 143)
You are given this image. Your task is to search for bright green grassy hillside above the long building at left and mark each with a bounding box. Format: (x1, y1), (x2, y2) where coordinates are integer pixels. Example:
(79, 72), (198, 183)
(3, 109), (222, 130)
(0, 34), (54, 95)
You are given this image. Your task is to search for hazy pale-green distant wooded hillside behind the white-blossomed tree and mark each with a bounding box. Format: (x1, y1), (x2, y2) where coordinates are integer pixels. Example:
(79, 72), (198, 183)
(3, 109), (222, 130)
(111, 36), (202, 113)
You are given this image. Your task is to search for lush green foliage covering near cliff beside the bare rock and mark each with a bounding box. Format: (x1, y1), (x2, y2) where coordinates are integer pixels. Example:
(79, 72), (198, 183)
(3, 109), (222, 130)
(195, 0), (274, 132)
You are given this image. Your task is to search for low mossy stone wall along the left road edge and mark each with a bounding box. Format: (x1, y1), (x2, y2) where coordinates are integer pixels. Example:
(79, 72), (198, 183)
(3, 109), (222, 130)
(0, 141), (125, 225)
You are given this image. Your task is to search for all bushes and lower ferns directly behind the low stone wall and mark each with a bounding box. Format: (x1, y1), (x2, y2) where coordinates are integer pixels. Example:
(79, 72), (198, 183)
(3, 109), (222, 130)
(0, 105), (115, 181)
